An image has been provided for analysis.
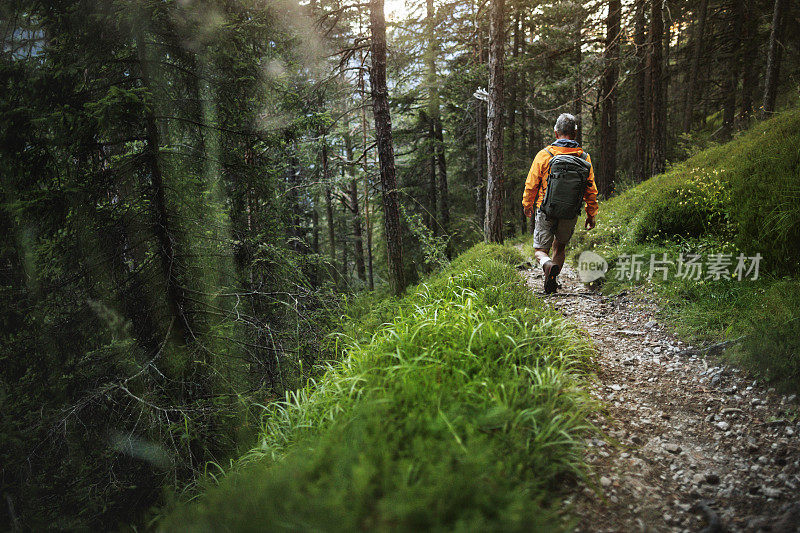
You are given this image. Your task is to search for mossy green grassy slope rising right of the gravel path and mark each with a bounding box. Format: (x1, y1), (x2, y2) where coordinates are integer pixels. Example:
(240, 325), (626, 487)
(573, 110), (800, 390)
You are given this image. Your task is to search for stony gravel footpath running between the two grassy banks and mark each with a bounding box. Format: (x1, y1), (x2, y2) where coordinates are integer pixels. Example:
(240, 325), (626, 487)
(522, 256), (800, 532)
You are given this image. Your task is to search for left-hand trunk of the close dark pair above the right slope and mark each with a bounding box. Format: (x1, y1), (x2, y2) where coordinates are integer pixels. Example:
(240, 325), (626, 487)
(633, 0), (650, 180)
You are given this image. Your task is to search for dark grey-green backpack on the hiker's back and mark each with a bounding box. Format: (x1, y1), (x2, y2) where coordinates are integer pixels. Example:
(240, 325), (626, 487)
(539, 150), (592, 219)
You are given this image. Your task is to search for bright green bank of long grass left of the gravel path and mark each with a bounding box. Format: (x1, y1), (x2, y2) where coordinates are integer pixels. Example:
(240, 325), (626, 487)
(161, 244), (595, 531)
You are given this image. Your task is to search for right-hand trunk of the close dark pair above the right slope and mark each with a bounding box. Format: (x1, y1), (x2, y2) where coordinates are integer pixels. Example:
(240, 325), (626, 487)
(648, 0), (666, 176)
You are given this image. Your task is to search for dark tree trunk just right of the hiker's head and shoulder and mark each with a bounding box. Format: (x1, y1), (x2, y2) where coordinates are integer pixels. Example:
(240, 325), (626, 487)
(597, 0), (622, 196)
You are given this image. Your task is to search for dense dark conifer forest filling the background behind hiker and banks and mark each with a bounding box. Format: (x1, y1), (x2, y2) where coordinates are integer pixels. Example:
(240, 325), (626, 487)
(0, 0), (800, 528)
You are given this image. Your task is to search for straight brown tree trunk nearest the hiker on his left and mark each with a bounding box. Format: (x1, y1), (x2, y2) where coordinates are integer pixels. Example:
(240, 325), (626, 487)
(483, 0), (506, 243)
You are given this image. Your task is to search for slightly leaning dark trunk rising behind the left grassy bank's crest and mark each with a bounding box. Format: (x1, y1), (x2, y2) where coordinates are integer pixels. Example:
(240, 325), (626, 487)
(369, 0), (406, 295)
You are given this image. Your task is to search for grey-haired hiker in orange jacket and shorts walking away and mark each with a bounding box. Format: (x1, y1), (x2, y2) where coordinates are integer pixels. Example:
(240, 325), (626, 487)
(522, 113), (597, 294)
